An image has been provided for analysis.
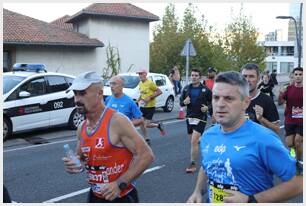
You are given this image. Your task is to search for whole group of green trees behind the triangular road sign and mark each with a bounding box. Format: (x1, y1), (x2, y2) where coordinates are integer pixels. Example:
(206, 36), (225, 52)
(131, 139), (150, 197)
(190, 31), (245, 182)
(150, 4), (265, 74)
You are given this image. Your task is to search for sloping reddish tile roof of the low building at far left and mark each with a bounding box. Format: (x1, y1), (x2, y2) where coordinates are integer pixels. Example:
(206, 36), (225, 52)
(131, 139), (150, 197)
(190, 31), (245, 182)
(3, 9), (104, 47)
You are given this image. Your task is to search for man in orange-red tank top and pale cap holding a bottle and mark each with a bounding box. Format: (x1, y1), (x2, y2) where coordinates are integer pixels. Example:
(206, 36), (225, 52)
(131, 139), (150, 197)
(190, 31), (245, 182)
(63, 72), (154, 203)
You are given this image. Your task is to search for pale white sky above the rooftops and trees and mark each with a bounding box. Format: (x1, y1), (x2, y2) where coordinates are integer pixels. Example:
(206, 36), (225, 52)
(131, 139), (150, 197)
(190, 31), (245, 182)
(3, 2), (289, 41)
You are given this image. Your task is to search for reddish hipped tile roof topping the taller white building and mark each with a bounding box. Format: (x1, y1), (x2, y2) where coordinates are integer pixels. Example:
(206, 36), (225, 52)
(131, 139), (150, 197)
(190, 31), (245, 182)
(67, 3), (159, 23)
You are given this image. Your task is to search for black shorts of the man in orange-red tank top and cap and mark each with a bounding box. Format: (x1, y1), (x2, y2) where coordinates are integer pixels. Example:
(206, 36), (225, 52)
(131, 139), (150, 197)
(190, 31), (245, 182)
(87, 188), (139, 203)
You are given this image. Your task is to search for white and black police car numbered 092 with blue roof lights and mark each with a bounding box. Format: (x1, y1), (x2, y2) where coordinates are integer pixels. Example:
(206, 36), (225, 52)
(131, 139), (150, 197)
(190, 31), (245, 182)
(3, 64), (84, 140)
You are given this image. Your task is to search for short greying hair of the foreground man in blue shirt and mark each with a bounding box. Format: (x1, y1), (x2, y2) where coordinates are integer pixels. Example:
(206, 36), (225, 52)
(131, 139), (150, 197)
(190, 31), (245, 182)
(215, 71), (249, 99)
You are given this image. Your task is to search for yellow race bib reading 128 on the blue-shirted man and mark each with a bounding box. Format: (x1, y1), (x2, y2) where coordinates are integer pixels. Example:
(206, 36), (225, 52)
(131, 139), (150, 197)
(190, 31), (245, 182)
(209, 180), (238, 203)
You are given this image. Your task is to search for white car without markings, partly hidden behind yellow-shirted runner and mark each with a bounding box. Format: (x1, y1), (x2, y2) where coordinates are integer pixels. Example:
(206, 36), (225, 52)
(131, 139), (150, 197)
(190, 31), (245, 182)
(104, 72), (175, 112)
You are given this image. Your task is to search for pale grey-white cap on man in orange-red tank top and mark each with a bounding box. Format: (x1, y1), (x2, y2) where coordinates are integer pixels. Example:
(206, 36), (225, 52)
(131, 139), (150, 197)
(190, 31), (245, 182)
(67, 71), (103, 91)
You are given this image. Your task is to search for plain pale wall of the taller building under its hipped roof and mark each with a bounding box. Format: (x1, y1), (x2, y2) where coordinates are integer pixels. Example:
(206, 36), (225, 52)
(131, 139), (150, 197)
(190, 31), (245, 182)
(79, 18), (149, 72)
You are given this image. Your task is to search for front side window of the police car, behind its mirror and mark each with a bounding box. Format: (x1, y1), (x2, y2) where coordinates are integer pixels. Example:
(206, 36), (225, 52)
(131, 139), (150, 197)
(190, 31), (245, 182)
(19, 77), (46, 97)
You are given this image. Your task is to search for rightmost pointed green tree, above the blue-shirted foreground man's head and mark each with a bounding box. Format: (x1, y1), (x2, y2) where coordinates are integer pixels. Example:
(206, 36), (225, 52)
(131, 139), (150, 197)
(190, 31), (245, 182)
(224, 7), (266, 71)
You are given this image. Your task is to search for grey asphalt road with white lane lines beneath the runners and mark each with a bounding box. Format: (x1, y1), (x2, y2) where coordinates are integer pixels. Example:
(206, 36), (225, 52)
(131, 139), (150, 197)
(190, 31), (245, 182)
(3, 101), (303, 203)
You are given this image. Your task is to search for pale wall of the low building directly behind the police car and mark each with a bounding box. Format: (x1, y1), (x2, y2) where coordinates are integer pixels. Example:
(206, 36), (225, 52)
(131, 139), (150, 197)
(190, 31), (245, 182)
(16, 47), (98, 75)
